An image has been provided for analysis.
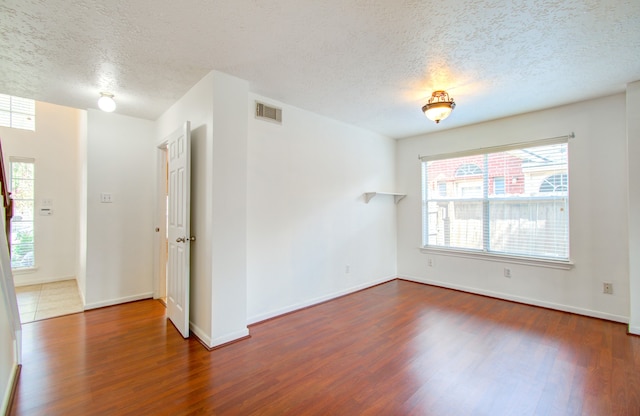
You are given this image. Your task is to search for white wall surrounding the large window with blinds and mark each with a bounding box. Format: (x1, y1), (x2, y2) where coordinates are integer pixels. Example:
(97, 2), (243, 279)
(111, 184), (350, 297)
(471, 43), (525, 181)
(396, 94), (631, 322)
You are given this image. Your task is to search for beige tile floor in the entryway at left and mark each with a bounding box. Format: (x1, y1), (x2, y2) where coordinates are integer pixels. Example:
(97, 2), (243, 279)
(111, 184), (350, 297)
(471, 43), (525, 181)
(16, 280), (83, 324)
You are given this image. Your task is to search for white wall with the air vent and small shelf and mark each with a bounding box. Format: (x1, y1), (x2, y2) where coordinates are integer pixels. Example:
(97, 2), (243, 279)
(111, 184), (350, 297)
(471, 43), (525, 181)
(247, 94), (404, 322)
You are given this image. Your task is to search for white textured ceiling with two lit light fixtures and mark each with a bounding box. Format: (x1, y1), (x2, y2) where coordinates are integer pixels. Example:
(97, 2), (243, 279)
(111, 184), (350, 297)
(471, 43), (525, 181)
(0, 0), (640, 138)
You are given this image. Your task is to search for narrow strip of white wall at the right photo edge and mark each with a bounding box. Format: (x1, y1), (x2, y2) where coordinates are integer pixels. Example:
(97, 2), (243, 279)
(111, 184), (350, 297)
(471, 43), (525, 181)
(627, 81), (640, 335)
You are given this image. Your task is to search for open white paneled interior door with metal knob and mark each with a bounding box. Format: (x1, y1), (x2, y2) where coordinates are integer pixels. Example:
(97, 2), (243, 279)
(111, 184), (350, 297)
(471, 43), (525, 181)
(167, 121), (191, 338)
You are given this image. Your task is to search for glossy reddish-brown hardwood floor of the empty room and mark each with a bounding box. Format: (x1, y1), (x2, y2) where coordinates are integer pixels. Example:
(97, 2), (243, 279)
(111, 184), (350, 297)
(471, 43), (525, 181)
(12, 280), (640, 416)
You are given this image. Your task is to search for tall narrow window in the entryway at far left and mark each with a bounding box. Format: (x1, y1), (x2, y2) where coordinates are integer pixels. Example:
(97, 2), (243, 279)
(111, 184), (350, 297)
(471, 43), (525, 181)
(11, 158), (35, 269)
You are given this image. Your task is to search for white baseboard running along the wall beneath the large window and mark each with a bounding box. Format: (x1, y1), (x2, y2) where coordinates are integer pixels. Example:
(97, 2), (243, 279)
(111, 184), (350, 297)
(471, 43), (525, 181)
(398, 276), (629, 324)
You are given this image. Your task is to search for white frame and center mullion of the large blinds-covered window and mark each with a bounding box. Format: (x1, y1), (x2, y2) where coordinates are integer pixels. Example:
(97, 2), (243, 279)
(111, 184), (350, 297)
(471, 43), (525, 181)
(420, 134), (573, 270)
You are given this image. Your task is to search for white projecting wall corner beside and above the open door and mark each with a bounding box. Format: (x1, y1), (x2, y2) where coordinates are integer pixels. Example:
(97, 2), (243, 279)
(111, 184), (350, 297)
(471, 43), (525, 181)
(156, 71), (249, 347)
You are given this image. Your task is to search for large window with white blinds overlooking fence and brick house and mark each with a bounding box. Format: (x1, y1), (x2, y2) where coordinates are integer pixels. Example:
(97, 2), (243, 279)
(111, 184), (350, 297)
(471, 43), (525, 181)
(422, 138), (569, 261)
